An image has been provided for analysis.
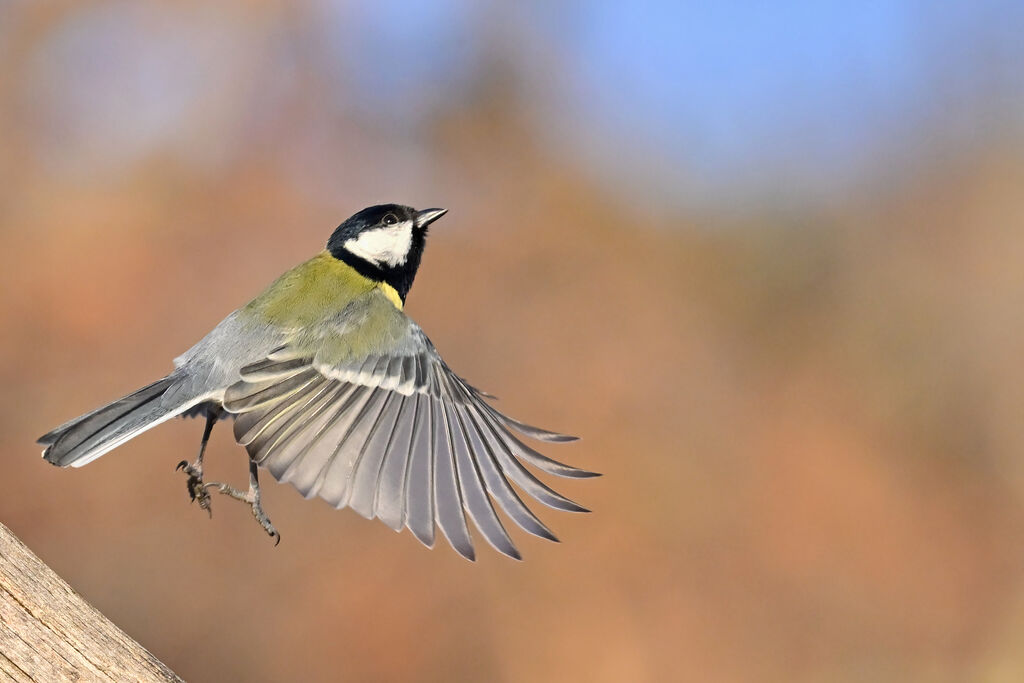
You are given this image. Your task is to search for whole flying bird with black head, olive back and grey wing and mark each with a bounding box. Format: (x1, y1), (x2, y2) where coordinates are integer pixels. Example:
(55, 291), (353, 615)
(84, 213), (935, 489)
(38, 204), (599, 561)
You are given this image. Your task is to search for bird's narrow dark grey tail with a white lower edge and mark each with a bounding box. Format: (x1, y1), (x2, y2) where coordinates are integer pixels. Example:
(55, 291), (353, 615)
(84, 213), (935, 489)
(38, 375), (189, 467)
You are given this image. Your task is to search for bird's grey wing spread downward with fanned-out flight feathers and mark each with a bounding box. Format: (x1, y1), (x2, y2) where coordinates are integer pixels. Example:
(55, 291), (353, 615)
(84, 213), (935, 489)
(224, 318), (595, 560)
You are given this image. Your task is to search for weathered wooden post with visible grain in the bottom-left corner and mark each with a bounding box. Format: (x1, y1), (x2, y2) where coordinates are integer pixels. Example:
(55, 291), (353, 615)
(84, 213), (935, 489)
(0, 524), (181, 683)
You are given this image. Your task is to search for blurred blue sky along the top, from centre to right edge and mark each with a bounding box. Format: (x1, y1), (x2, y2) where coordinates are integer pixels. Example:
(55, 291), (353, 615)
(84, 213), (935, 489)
(325, 0), (1024, 205)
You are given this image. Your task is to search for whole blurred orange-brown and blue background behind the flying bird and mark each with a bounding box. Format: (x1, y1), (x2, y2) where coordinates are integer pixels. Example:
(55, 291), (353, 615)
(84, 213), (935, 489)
(0, 0), (1024, 681)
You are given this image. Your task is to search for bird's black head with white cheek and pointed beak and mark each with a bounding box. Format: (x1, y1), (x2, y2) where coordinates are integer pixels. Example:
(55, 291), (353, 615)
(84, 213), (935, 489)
(327, 204), (447, 301)
